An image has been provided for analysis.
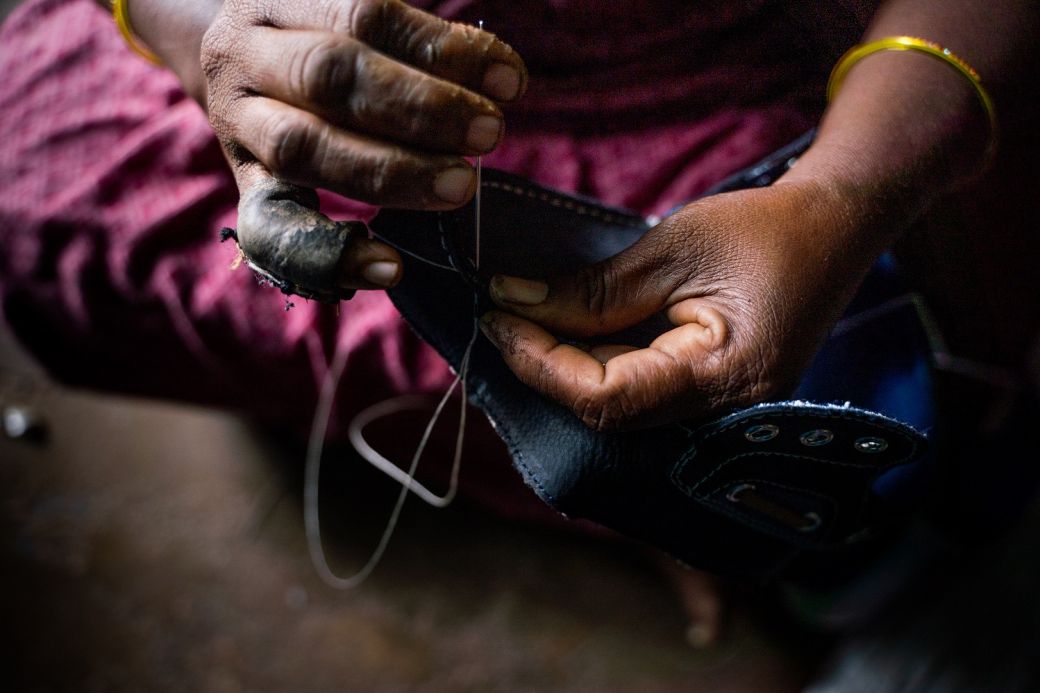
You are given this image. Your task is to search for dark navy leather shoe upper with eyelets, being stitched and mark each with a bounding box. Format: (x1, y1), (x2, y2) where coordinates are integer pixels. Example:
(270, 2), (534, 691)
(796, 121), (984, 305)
(370, 133), (934, 579)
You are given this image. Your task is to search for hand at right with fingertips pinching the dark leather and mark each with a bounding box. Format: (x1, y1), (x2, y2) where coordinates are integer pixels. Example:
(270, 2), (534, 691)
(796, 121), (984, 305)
(482, 176), (890, 430)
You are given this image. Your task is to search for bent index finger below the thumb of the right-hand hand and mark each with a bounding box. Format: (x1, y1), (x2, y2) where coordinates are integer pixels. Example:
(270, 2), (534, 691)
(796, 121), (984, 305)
(482, 311), (718, 431)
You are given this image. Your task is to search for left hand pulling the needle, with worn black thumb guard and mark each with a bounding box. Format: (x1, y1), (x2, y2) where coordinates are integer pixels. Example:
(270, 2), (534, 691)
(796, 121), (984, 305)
(202, 0), (526, 288)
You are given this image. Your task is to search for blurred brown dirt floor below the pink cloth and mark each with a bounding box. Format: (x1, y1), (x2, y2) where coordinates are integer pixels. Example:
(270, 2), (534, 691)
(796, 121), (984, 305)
(0, 324), (827, 692)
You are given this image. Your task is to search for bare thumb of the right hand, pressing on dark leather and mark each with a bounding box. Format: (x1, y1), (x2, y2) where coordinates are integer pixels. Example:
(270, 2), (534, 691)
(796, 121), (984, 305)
(490, 234), (678, 336)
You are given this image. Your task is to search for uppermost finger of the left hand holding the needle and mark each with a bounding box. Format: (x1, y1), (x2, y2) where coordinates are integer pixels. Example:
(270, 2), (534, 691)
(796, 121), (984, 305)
(252, 0), (527, 101)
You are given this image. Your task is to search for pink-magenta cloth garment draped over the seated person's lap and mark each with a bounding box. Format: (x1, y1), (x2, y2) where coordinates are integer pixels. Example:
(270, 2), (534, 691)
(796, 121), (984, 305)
(0, 0), (824, 516)
